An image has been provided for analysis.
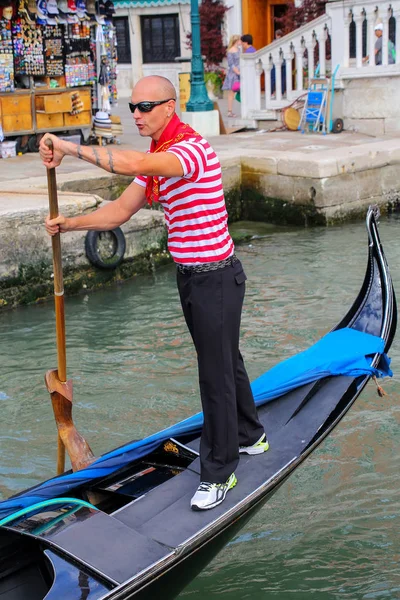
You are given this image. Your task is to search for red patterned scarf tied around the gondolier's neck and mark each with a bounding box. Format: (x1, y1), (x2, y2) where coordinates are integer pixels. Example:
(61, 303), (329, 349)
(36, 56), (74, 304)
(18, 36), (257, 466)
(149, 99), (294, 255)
(146, 114), (201, 206)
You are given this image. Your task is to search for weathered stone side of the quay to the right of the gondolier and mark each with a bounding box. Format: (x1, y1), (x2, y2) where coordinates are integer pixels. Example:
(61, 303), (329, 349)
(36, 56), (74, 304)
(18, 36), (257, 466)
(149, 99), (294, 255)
(234, 140), (400, 225)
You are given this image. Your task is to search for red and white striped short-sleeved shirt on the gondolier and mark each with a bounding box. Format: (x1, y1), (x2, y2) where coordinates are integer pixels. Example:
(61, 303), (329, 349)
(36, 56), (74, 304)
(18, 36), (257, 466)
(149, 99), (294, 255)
(135, 138), (234, 265)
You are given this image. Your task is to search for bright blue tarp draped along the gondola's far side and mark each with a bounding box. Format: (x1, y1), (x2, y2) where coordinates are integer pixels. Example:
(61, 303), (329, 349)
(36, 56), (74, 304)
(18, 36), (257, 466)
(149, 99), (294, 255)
(0, 328), (392, 518)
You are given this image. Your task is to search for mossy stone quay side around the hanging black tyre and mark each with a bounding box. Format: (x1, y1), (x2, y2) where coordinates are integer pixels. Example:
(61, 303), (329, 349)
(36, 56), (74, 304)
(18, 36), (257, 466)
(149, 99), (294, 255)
(0, 189), (166, 308)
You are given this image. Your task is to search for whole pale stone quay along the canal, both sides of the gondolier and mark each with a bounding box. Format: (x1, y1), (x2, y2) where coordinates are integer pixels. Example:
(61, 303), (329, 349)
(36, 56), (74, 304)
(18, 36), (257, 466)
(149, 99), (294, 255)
(0, 130), (400, 308)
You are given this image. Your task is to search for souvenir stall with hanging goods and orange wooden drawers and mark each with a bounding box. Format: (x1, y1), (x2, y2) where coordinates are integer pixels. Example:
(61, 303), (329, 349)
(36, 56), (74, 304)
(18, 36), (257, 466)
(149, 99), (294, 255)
(0, 0), (117, 158)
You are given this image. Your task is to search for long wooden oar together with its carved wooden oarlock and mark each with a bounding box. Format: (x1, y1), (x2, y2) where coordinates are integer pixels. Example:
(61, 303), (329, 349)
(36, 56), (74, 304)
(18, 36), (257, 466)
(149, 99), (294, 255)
(45, 140), (95, 475)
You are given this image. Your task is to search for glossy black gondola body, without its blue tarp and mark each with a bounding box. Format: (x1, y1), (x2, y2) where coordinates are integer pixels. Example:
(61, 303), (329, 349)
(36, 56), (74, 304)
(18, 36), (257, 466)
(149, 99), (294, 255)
(0, 209), (397, 600)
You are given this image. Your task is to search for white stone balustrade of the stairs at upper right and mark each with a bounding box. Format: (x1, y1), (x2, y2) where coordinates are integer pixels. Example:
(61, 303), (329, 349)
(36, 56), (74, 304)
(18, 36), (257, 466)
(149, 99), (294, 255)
(240, 0), (400, 120)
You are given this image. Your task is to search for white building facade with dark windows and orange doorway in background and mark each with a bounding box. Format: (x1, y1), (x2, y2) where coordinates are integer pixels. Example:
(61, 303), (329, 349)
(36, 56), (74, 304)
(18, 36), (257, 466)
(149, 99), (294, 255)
(114, 0), (288, 97)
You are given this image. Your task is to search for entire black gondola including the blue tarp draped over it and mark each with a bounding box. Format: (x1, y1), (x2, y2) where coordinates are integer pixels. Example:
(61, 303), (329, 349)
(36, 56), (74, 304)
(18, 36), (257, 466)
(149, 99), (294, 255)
(0, 207), (397, 600)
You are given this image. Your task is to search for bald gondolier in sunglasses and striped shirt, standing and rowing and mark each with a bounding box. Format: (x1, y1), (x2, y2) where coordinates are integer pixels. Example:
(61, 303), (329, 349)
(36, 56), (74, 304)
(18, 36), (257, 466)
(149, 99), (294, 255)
(40, 76), (268, 510)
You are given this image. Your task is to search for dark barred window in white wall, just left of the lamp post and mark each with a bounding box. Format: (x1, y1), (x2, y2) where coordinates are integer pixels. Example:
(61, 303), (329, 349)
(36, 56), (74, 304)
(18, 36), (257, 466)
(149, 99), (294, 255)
(141, 15), (181, 63)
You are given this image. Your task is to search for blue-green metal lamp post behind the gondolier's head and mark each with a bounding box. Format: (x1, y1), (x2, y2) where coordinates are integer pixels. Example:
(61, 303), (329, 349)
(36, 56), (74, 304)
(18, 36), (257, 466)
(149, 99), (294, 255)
(186, 0), (214, 112)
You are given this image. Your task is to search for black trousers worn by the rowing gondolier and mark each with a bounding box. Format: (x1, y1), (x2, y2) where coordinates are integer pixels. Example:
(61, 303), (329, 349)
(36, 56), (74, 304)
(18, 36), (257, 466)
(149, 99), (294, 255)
(177, 261), (264, 483)
